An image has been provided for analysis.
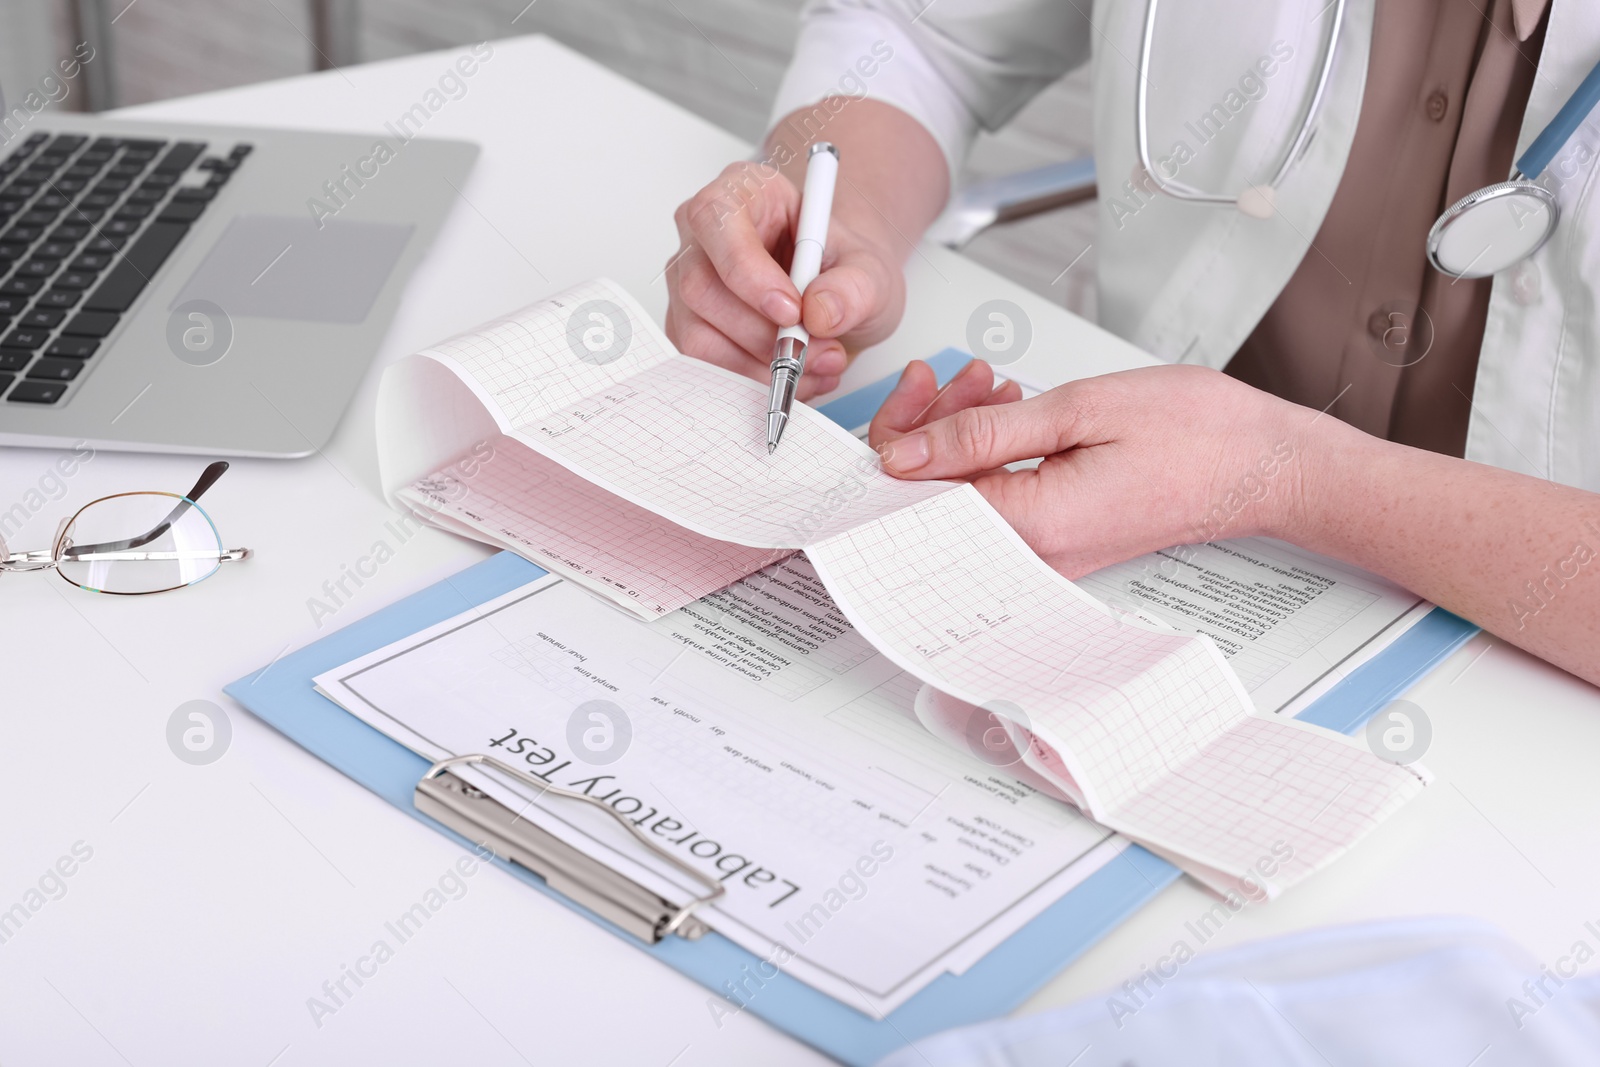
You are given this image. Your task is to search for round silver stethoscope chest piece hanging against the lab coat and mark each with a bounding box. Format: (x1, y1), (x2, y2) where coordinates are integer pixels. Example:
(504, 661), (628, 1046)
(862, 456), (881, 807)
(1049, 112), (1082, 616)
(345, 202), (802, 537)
(1427, 179), (1560, 278)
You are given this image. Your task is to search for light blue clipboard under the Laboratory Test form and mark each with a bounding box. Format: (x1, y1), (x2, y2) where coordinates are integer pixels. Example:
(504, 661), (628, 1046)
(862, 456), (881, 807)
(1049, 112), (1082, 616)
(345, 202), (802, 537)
(224, 349), (1477, 1065)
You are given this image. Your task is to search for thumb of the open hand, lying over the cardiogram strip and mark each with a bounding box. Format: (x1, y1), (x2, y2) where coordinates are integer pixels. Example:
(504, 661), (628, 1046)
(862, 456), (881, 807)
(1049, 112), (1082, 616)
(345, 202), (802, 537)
(878, 382), (1101, 478)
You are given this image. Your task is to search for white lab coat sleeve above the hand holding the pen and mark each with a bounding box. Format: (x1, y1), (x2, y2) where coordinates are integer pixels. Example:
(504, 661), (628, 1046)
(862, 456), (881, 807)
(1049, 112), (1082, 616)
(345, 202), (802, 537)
(771, 0), (1093, 187)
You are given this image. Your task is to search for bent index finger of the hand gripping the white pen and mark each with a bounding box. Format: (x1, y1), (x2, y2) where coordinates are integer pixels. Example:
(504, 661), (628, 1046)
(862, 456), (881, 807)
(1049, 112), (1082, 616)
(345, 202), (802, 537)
(678, 163), (800, 326)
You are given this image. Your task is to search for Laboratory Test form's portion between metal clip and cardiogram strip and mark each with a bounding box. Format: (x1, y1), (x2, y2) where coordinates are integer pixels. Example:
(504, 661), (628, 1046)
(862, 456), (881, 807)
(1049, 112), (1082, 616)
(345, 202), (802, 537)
(317, 557), (1125, 1016)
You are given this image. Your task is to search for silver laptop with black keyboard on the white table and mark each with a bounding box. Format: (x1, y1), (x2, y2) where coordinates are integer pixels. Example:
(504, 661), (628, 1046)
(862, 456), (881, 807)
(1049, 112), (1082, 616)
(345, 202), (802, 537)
(0, 115), (478, 458)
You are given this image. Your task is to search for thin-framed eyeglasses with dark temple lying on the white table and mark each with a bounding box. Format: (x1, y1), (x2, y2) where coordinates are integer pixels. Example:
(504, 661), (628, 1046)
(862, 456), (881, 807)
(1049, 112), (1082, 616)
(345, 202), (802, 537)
(0, 461), (250, 597)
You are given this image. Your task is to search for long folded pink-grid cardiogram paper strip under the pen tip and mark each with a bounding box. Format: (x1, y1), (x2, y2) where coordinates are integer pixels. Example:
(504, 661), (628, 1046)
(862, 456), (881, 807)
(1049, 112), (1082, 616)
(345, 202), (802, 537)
(384, 282), (1426, 893)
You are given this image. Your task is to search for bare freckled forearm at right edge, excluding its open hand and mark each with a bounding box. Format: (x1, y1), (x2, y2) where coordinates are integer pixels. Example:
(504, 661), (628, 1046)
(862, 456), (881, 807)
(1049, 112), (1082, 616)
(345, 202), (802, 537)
(1275, 419), (1600, 685)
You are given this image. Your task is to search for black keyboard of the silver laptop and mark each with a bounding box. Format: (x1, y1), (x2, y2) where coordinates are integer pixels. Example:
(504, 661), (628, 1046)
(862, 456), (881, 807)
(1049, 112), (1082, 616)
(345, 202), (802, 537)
(0, 133), (251, 405)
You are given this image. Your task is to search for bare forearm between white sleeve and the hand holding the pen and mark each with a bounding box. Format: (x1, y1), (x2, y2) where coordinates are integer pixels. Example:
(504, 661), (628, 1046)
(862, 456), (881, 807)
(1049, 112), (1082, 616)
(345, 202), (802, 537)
(763, 96), (950, 262)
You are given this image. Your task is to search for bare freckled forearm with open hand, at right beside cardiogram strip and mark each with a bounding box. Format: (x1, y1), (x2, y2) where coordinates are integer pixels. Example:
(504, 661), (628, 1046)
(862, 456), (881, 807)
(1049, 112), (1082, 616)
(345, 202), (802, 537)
(870, 363), (1600, 685)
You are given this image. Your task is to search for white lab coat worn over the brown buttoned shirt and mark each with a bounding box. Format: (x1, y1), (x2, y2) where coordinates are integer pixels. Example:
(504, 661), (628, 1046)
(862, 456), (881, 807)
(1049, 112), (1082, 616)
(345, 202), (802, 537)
(774, 0), (1600, 491)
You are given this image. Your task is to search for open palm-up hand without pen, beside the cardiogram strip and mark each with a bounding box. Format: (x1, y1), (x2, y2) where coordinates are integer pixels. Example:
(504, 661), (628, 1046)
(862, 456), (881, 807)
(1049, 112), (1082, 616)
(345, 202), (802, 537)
(869, 360), (1324, 577)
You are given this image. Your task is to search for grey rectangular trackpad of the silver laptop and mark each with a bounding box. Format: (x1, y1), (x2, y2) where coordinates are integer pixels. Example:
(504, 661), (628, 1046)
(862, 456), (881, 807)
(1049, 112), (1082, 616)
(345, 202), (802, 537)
(168, 214), (413, 323)
